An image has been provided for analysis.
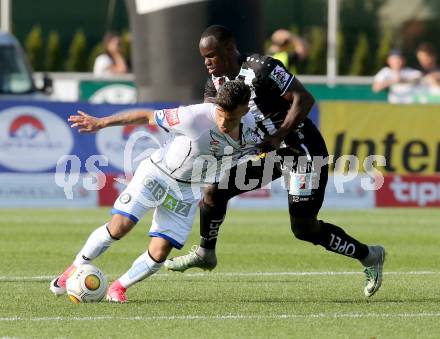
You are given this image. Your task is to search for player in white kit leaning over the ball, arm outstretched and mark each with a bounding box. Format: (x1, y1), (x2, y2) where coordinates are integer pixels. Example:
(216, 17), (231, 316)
(50, 80), (260, 302)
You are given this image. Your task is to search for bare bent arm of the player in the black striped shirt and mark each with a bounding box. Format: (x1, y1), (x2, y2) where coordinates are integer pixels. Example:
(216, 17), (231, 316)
(263, 78), (315, 149)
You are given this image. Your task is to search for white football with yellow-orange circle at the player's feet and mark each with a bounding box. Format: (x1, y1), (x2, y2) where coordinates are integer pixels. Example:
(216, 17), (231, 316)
(66, 264), (107, 304)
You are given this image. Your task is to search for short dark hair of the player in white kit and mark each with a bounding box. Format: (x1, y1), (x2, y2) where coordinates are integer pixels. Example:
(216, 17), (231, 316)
(215, 80), (251, 111)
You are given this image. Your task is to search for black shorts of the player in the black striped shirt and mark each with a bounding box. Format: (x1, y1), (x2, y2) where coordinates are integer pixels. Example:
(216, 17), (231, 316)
(215, 119), (328, 218)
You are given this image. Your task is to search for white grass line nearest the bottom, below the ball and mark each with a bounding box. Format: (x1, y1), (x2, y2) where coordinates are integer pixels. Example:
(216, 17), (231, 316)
(0, 313), (440, 322)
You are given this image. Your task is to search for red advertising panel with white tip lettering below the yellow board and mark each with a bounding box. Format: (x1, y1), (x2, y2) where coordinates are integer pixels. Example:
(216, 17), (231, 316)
(376, 175), (440, 207)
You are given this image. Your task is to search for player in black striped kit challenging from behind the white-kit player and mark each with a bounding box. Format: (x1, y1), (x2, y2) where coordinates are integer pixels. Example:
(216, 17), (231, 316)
(165, 25), (385, 297)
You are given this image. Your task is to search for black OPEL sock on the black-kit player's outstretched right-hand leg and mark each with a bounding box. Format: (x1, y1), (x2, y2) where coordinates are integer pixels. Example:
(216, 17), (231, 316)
(319, 220), (369, 260)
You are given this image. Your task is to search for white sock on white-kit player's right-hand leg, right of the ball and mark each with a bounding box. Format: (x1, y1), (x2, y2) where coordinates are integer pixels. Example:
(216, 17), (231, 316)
(118, 252), (163, 288)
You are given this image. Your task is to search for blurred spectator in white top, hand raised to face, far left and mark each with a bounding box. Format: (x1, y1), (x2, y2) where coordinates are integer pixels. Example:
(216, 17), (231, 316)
(93, 33), (128, 76)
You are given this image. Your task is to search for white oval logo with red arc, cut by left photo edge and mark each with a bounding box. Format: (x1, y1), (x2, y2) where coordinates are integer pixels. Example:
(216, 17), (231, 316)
(0, 106), (73, 172)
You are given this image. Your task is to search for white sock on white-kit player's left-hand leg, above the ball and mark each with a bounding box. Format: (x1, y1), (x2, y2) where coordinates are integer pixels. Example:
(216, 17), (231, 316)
(73, 224), (116, 266)
